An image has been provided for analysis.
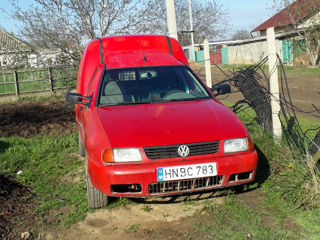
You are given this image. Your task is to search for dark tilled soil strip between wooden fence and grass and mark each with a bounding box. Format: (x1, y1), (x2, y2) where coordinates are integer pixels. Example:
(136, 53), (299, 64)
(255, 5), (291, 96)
(0, 99), (76, 138)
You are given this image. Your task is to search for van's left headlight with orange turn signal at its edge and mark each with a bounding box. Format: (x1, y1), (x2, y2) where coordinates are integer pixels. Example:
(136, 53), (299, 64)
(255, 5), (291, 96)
(102, 148), (142, 162)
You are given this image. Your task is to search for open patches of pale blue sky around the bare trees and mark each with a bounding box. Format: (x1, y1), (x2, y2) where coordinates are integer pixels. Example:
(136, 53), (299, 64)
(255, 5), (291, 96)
(0, 0), (273, 39)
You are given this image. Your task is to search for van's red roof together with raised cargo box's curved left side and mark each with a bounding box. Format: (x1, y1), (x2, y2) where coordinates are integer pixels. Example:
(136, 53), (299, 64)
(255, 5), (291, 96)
(77, 35), (188, 94)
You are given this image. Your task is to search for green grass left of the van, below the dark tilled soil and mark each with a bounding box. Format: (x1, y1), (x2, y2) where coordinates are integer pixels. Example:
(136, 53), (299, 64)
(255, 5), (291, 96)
(0, 134), (89, 226)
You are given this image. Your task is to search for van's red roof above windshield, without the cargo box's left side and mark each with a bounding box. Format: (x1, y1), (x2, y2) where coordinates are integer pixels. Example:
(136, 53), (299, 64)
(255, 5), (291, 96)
(102, 35), (188, 68)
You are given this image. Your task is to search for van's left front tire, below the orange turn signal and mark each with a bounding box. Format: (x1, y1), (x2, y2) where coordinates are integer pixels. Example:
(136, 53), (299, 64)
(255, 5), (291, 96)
(86, 157), (109, 208)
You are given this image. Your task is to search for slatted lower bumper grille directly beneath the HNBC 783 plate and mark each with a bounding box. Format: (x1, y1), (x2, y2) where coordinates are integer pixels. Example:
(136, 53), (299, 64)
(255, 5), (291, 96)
(149, 176), (223, 194)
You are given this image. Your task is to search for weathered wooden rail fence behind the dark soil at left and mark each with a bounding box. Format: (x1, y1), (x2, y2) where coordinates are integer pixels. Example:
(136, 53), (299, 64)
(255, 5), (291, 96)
(0, 67), (77, 96)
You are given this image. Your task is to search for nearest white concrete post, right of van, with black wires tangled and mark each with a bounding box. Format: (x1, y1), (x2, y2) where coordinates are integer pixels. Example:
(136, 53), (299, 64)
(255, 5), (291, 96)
(267, 27), (282, 139)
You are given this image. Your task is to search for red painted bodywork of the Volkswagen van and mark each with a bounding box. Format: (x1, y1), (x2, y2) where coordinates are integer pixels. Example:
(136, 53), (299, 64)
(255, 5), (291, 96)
(75, 36), (257, 196)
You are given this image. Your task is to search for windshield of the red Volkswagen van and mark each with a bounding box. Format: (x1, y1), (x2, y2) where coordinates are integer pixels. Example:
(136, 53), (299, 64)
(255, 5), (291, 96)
(99, 66), (211, 106)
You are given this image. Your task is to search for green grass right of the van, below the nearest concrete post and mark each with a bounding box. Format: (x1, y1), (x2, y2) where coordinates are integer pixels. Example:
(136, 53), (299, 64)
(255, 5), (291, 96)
(188, 120), (320, 240)
